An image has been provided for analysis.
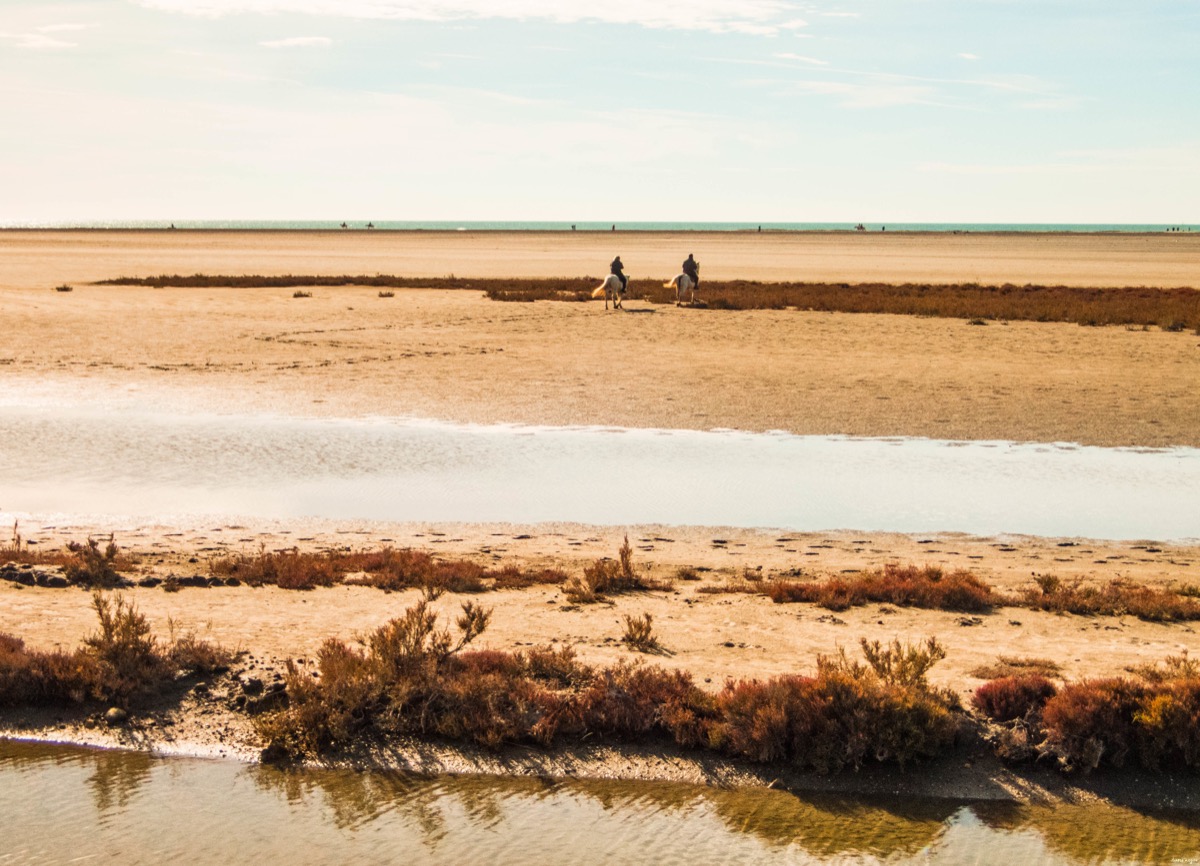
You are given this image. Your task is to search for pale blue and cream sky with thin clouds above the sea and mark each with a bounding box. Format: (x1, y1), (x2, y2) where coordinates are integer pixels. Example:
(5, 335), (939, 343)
(0, 0), (1200, 224)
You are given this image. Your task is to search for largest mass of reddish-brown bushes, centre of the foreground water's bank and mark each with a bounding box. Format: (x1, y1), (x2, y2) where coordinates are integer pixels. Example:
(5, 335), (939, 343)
(256, 611), (956, 772)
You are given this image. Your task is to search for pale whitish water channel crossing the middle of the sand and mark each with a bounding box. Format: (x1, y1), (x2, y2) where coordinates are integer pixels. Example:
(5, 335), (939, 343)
(0, 404), (1200, 540)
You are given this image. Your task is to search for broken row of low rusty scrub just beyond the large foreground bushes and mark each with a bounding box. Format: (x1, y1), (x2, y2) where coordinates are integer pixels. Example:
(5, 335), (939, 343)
(9, 527), (1200, 623)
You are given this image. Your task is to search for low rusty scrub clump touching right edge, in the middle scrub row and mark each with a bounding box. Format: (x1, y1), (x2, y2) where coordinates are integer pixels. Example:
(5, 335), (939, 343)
(1021, 575), (1200, 623)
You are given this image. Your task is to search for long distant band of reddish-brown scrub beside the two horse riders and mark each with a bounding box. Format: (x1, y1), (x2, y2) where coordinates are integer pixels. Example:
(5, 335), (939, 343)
(102, 273), (1200, 331)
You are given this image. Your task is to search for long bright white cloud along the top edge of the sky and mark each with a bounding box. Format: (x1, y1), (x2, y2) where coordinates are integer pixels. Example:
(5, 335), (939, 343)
(134, 0), (825, 36)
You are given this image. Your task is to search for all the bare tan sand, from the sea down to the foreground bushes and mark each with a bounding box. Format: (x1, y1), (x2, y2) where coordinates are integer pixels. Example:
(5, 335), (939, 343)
(0, 231), (1200, 796)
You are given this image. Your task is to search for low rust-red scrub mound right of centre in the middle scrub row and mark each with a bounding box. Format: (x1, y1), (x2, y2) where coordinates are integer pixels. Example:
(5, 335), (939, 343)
(762, 563), (997, 611)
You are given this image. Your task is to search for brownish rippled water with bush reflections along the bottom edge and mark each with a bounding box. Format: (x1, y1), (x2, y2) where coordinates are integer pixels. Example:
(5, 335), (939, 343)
(0, 740), (1200, 866)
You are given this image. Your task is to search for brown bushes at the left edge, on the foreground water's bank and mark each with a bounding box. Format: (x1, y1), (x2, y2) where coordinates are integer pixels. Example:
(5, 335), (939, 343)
(0, 593), (233, 706)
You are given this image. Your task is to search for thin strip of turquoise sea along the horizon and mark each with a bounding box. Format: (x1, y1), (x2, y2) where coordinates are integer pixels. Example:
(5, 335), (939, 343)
(0, 219), (1200, 234)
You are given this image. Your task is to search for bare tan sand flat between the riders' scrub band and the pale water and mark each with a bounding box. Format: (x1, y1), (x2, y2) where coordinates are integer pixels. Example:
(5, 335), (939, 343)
(0, 279), (1200, 447)
